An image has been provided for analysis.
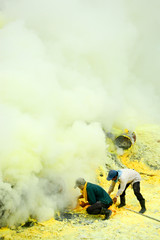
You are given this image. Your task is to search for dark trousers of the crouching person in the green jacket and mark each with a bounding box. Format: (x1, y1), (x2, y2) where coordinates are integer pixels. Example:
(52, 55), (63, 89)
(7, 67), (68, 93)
(86, 201), (112, 215)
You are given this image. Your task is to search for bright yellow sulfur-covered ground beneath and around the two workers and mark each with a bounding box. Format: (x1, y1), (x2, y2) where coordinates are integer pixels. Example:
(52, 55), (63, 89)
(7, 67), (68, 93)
(0, 125), (160, 240)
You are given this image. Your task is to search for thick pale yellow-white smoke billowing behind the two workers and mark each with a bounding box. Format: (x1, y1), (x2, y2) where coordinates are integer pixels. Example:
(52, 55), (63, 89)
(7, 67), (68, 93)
(0, 0), (160, 224)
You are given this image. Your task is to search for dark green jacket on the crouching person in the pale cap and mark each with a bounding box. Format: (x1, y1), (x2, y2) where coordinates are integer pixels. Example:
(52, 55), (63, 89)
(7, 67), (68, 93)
(86, 182), (112, 205)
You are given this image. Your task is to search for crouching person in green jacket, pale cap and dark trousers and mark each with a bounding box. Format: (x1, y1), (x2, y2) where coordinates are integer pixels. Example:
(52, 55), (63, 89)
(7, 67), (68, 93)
(74, 178), (113, 220)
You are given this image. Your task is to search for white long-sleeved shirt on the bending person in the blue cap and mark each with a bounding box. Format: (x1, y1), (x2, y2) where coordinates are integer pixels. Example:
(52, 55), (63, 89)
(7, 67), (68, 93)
(108, 169), (141, 197)
